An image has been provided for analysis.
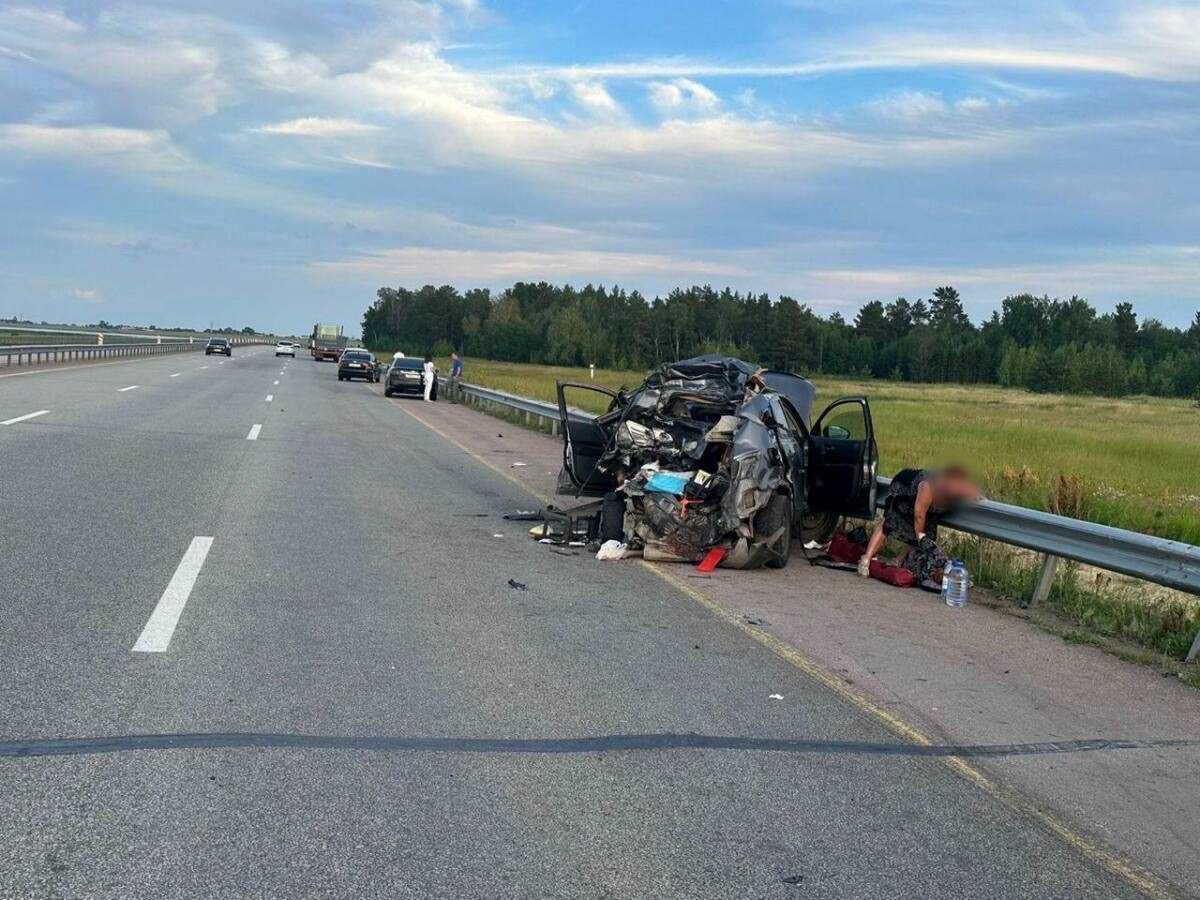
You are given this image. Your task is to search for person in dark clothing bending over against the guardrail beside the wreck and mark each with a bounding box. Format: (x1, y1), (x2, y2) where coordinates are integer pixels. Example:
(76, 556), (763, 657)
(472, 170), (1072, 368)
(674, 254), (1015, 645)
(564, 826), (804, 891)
(858, 466), (983, 583)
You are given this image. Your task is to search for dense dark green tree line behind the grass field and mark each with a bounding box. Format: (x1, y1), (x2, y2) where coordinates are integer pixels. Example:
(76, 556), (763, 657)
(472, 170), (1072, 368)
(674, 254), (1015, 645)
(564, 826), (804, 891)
(362, 282), (1200, 397)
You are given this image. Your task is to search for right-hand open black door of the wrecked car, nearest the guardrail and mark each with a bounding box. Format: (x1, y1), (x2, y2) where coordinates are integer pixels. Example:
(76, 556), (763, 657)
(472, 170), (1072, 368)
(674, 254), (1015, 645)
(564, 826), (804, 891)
(809, 397), (880, 518)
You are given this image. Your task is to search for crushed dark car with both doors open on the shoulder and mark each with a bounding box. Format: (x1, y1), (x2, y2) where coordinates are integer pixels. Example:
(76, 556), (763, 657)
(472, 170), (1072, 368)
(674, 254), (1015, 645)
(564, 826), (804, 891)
(554, 354), (878, 569)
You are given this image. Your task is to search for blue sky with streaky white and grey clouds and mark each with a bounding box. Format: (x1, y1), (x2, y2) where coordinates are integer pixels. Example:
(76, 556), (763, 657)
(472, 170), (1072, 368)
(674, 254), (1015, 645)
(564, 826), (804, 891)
(0, 0), (1200, 334)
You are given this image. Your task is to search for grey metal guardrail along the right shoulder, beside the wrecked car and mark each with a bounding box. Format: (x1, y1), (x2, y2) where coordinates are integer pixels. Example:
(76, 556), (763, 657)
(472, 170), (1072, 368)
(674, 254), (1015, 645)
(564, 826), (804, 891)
(448, 382), (1200, 662)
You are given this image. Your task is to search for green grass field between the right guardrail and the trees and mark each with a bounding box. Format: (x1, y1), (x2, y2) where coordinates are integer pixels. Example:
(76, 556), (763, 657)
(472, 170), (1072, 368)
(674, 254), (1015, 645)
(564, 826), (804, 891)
(432, 354), (1200, 544)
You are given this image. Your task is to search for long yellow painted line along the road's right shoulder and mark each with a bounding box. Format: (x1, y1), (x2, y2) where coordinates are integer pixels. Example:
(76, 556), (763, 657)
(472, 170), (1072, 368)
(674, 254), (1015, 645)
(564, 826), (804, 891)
(392, 401), (1180, 900)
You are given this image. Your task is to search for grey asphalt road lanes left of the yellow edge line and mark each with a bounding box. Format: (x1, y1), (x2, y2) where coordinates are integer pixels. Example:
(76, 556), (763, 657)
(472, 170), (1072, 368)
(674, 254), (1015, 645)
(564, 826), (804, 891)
(0, 349), (1152, 898)
